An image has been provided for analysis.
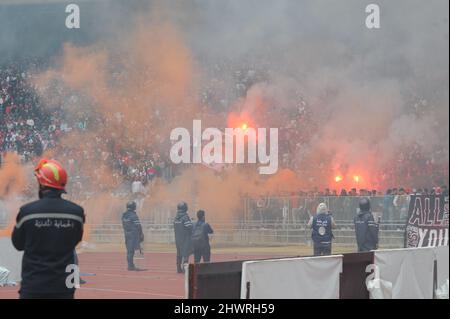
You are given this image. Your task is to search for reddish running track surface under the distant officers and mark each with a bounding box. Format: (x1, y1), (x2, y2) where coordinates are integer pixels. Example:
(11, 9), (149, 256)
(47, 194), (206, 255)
(0, 253), (284, 299)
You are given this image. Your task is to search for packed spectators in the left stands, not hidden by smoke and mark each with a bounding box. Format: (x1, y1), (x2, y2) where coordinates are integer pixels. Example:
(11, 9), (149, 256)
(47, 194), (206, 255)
(0, 62), (170, 191)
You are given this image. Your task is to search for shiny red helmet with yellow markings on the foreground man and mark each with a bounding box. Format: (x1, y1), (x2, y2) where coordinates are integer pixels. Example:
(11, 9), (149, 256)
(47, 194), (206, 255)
(34, 158), (67, 190)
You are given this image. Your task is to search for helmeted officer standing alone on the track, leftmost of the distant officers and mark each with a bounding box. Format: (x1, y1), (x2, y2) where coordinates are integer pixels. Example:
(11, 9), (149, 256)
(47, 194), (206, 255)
(122, 201), (144, 271)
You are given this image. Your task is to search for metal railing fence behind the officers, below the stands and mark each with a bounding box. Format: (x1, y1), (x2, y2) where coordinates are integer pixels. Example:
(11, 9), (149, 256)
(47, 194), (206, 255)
(0, 196), (408, 247)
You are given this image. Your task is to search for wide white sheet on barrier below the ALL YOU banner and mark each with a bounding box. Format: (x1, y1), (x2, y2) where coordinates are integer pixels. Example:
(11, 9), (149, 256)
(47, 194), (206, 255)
(370, 248), (435, 299)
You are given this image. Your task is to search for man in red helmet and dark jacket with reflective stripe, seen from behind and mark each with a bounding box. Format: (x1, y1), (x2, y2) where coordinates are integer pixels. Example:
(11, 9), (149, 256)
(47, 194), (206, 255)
(12, 159), (85, 299)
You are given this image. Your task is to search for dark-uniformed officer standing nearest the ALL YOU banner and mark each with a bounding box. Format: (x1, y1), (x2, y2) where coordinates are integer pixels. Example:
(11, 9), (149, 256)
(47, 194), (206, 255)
(354, 197), (379, 252)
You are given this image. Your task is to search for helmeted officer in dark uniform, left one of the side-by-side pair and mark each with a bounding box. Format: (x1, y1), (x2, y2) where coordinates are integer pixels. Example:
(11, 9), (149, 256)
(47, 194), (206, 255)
(173, 202), (192, 273)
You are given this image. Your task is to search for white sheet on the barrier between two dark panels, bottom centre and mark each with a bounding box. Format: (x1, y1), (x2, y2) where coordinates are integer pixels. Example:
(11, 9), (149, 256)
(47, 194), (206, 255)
(241, 255), (343, 299)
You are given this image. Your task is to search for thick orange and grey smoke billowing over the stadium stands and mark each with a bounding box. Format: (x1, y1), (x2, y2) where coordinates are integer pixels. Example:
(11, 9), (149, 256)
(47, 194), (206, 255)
(0, 0), (449, 228)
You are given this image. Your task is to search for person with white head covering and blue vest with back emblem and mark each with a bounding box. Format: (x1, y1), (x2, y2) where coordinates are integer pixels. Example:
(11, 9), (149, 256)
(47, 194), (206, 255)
(308, 203), (336, 256)
